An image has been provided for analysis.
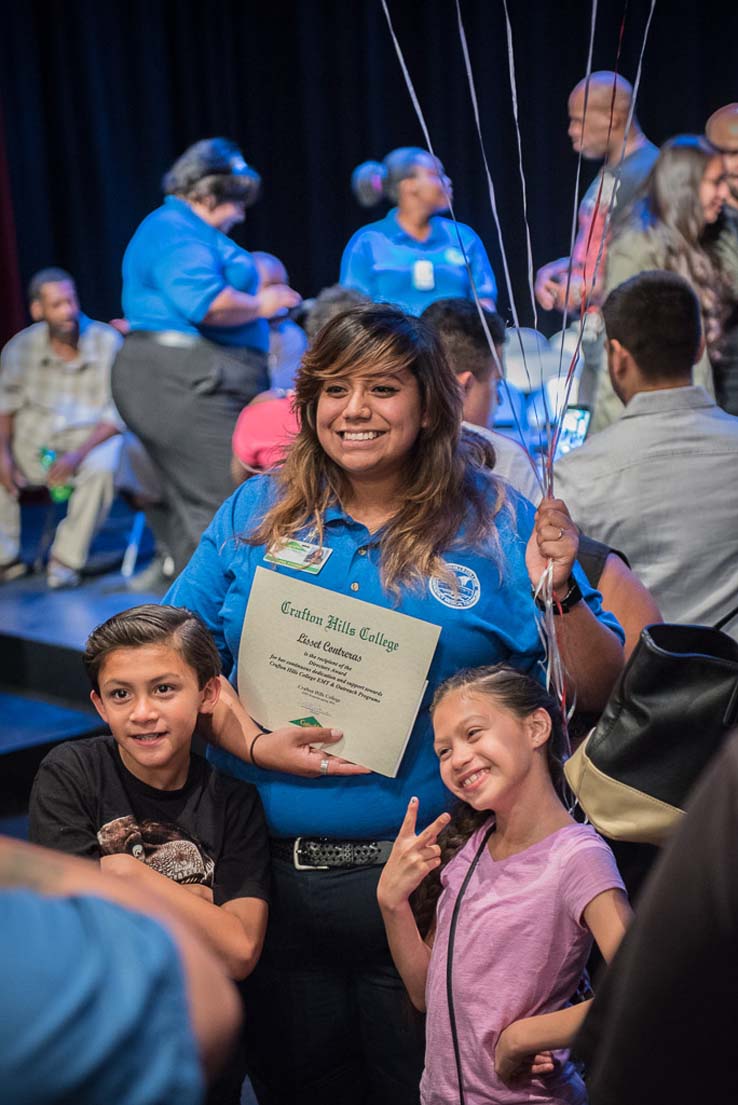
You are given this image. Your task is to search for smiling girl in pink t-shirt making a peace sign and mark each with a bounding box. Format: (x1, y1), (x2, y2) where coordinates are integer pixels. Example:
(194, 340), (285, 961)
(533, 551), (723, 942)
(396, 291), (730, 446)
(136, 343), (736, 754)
(377, 665), (630, 1105)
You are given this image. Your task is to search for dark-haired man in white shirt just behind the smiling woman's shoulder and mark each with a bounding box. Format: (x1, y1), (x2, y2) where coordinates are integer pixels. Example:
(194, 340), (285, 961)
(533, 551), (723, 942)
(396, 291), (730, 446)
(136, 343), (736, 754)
(421, 298), (541, 503)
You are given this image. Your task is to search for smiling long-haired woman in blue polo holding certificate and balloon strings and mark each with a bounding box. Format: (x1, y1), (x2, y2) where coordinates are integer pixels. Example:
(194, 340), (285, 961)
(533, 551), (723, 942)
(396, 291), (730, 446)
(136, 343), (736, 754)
(166, 305), (622, 1105)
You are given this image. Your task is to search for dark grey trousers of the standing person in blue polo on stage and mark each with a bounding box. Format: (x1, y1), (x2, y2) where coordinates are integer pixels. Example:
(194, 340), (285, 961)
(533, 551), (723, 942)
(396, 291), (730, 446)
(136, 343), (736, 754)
(113, 333), (268, 571)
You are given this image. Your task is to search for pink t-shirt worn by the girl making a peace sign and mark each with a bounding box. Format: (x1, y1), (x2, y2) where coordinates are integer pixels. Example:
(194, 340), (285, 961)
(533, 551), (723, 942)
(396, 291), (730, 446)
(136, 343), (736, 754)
(421, 822), (623, 1105)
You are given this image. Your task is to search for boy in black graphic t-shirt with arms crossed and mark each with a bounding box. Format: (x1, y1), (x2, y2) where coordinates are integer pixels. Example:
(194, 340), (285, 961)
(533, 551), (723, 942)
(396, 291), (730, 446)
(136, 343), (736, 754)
(30, 606), (270, 978)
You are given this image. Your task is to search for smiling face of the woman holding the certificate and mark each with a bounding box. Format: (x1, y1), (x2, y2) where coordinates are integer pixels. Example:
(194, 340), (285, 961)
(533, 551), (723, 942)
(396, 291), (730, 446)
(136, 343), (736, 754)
(316, 367), (424, 480)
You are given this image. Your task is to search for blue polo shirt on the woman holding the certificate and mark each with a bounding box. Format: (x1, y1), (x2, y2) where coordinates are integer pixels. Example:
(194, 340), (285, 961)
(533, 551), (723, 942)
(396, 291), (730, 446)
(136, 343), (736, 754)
(164, 475), (622, 839)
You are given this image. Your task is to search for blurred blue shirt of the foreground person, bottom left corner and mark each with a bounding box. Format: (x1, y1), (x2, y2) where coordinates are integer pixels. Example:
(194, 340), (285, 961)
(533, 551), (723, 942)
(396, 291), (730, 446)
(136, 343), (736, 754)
(0, 890), (203, 1105)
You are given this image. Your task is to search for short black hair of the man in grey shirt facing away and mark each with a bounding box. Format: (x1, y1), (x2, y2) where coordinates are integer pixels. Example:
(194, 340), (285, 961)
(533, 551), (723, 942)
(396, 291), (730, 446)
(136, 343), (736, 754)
(602, 269), (702, 380)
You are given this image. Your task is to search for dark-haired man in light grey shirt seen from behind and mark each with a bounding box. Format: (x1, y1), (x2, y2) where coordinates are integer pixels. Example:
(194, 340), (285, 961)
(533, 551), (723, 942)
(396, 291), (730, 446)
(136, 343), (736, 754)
(556, 271), (738, 634)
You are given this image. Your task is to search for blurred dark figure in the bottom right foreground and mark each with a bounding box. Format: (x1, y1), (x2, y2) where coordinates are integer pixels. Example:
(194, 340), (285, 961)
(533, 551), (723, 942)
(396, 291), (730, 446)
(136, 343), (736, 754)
(573, 733), (738, 1105)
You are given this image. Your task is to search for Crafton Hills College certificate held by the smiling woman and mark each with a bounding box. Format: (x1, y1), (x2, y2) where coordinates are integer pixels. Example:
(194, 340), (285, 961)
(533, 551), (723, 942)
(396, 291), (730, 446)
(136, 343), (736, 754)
(239, 568), (441, 776)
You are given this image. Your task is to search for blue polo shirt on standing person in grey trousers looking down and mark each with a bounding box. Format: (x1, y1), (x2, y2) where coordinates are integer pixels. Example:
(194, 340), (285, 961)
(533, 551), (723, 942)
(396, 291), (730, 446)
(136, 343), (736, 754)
(123, 196), (270, 352)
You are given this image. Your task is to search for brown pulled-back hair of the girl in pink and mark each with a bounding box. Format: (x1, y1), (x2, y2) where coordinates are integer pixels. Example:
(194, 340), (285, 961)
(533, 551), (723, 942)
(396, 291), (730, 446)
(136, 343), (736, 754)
(410, 664), (566, 938)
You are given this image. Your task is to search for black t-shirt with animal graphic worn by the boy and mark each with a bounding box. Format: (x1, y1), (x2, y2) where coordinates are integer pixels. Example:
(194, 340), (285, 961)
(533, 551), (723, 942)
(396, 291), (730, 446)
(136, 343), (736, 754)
(30, 736), (270, 905)
